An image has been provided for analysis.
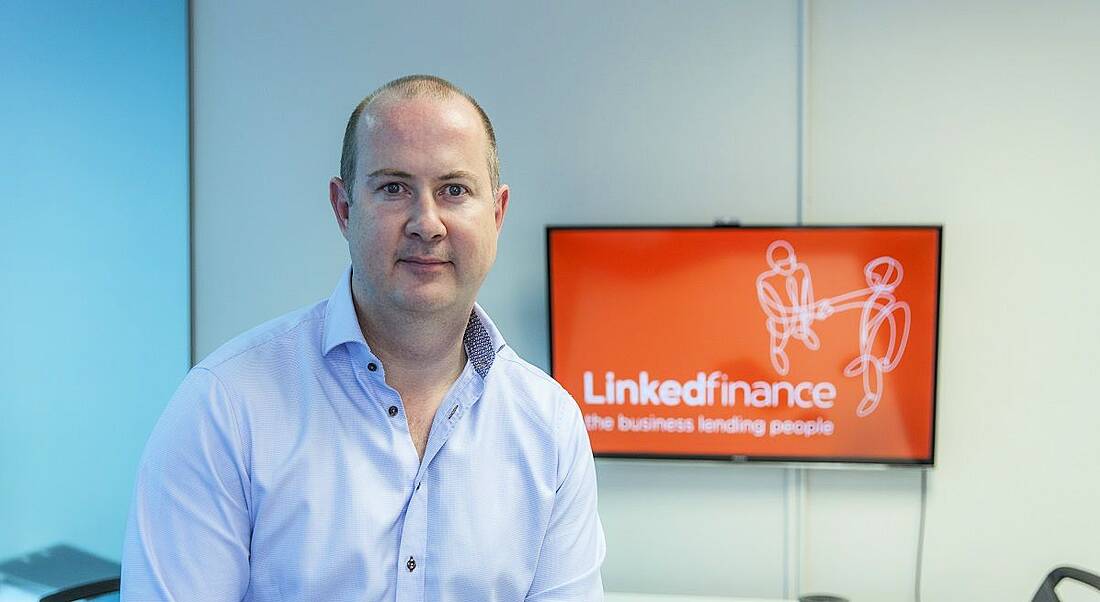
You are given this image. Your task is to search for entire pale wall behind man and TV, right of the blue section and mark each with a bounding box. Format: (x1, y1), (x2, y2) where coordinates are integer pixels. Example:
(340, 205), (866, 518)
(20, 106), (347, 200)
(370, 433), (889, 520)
(194, 0), (1100, 602)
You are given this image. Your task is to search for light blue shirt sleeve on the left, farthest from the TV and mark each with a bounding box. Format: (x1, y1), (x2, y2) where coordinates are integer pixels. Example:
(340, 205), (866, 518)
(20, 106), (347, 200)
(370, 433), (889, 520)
(121, 368), (252, 602)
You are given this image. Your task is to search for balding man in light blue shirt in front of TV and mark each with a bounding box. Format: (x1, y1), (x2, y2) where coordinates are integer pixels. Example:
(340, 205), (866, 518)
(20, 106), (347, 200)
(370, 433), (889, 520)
(122, 76), (605, 601)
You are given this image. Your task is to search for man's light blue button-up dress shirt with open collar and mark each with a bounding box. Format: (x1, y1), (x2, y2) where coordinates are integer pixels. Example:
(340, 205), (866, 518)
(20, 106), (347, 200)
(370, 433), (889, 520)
(122, 270), (605, 602)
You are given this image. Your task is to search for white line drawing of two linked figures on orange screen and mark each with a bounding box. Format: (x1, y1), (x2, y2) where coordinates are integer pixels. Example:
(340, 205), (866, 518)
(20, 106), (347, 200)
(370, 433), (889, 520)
(757, 240), (912, 417)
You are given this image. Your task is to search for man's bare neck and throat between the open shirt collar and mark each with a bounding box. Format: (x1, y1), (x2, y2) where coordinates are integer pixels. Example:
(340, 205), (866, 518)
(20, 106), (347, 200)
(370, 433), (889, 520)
(355, 292), (473, 403)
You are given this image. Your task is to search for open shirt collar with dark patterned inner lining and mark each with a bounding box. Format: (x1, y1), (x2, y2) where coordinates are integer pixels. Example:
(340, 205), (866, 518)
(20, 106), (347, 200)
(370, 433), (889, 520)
(321, 265), (505, 379)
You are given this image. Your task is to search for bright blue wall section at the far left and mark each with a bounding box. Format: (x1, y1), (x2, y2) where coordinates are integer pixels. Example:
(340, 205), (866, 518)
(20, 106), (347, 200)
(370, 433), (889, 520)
(0, 0), (190, 559)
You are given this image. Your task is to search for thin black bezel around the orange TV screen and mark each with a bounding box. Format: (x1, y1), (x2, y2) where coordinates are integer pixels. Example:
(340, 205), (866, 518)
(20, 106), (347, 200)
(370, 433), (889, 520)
(543, 222), (944, 469)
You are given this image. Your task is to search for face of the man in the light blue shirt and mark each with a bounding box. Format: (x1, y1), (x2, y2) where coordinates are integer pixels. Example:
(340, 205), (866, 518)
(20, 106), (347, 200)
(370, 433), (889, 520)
(332, 96), (508, 313)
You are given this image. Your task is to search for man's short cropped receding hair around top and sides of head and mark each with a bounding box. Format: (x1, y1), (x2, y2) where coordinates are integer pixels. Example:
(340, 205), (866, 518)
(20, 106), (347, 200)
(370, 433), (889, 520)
(340, 75), (501, 201)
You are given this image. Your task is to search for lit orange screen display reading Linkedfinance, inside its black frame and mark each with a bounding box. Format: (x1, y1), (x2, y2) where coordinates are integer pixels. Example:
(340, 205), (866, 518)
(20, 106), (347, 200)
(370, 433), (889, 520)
(547, 226), (942, 464)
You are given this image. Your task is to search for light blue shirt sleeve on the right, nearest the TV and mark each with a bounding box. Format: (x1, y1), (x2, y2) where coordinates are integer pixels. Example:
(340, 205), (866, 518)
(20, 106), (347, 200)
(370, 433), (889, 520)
(527, 397), (606, 602)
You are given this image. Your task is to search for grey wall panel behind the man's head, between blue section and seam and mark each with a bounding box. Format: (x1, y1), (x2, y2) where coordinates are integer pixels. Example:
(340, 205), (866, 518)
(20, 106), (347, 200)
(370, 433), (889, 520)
(194, 0), (798, 595)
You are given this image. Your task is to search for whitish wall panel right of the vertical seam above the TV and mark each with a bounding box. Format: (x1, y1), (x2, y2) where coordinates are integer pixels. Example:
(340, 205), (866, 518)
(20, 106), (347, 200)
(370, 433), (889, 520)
(805, 0), (1100, 601)
